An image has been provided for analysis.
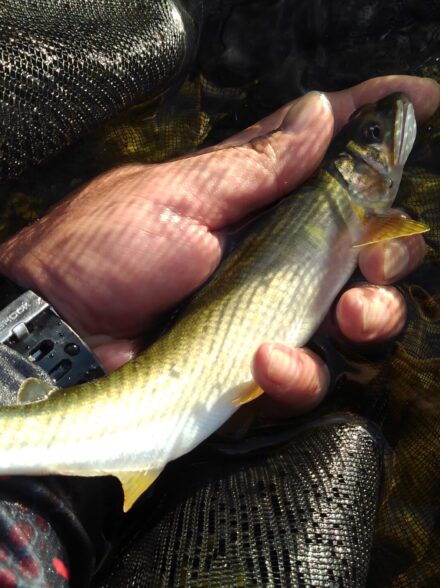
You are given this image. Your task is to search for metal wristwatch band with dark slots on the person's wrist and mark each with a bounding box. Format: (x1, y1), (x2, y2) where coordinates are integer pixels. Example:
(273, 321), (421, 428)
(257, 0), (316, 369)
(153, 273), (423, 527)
(0, 277), (105, 388)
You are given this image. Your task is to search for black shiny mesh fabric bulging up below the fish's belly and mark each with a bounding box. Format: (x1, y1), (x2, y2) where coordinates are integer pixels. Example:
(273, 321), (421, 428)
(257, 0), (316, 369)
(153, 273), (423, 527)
(94, 418), (382, 587)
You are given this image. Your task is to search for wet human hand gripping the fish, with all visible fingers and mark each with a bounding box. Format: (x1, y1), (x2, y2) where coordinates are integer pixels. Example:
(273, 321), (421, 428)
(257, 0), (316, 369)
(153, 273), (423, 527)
(0, 76), (440, 413)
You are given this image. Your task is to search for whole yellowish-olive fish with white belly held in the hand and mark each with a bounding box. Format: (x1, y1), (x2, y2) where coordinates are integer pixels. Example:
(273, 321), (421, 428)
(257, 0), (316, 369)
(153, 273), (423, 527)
(0, 93), (428, 510)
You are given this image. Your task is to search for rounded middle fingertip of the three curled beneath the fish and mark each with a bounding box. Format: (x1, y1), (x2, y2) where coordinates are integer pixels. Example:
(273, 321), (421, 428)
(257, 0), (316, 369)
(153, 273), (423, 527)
(336, 285), (406, 343)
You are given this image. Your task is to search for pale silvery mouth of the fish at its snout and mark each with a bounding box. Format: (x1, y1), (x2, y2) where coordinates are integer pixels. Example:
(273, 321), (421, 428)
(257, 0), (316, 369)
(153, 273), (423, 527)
(384, 92), (417, 170)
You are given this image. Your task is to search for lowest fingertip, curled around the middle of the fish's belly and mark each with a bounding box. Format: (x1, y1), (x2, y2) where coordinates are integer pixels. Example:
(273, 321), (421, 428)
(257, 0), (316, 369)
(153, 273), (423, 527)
(252, 343), (330, 415)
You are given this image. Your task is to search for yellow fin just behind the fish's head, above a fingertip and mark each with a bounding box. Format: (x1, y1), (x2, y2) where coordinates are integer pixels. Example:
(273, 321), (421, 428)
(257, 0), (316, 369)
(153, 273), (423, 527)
(353, 214), (429, 247)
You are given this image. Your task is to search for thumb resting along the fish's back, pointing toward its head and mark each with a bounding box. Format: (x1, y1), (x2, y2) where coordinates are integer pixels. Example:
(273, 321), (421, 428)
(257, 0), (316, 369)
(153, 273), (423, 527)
(158, 92), (334, 230)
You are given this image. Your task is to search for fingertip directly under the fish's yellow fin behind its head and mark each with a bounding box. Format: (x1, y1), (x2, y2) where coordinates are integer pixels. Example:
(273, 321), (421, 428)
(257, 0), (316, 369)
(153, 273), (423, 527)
(359, 235), (426, 284)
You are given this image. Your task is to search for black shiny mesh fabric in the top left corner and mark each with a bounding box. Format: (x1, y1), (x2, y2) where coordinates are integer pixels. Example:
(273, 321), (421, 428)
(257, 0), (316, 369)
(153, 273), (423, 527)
(0, 0), (199, 180)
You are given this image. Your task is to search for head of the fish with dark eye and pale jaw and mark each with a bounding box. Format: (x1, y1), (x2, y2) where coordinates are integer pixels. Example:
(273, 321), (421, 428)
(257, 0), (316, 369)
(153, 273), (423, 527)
(329, 92), (417, 216)
